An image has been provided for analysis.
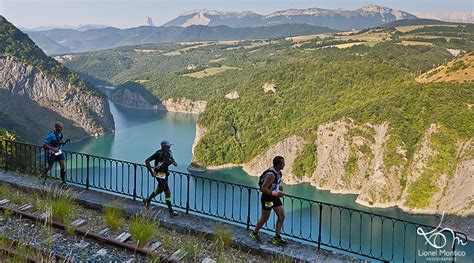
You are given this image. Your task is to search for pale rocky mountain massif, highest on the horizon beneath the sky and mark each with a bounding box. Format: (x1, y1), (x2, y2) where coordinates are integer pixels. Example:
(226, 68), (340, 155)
(164, 5), (416, 30)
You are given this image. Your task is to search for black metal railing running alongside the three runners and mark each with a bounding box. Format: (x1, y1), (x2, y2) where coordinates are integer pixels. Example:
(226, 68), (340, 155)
(0, 141), (467, 262)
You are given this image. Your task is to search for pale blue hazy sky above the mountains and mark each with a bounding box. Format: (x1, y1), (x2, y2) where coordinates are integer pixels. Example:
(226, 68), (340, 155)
(0, 0), (474, 28)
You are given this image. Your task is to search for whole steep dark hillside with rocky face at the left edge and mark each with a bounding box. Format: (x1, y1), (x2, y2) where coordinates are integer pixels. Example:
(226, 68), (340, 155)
(0, 17), (114, 142)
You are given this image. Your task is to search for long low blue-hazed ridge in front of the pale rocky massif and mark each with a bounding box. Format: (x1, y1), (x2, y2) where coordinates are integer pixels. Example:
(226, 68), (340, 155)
(27, 24), (337, 55)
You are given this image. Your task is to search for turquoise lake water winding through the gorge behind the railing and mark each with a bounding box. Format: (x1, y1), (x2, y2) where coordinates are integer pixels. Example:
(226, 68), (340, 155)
(64, 100), (474, 262)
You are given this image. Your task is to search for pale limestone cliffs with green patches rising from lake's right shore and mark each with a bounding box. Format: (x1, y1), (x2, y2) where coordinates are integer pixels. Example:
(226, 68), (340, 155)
(194, 119), (474, 216)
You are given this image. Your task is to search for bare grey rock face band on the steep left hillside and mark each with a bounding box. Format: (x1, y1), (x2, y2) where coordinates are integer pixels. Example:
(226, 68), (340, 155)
(0, 54), (114, 138)
